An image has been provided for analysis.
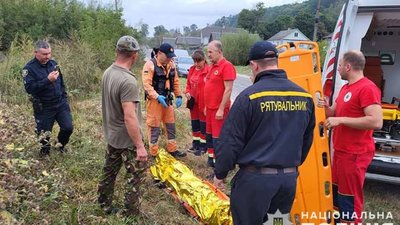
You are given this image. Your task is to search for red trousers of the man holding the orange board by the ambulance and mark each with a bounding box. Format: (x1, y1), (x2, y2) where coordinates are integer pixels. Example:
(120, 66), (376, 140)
(332, 151), (375, 223)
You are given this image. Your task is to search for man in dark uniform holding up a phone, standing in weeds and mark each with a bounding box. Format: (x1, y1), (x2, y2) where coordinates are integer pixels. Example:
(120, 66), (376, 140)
(22, 41), (73, 156)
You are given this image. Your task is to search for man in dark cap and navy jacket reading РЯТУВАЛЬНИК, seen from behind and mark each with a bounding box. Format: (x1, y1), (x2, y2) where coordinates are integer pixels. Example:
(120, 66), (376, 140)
(214, 41), (315, 225)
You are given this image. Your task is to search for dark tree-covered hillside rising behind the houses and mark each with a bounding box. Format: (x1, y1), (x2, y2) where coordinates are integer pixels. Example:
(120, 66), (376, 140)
(219, 0), (346, 40)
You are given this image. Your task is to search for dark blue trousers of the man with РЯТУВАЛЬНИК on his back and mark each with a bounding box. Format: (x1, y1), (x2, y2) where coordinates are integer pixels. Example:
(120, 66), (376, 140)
(230, 169), (298, 225)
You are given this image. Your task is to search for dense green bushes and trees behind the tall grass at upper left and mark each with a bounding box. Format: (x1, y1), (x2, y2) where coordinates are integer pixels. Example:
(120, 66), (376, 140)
(0, 0), (142, 69)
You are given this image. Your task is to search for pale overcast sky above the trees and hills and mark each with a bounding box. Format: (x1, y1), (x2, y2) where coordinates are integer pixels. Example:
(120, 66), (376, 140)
(122, 0), (304, 34)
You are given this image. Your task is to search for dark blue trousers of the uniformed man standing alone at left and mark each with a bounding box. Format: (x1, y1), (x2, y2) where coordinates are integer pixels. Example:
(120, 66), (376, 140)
(34, 101), (73, 148)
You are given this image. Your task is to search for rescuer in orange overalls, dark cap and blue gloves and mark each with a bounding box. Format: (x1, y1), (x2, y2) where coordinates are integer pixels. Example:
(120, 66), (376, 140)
(142, 43), (186, 157)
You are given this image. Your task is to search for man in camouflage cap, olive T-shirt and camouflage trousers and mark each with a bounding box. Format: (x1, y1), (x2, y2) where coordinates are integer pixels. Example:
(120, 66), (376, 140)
(98, 36), (147, 216)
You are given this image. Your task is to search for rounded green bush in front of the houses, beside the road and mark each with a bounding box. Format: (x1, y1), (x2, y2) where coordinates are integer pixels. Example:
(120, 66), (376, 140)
(221, 32), (260, 65)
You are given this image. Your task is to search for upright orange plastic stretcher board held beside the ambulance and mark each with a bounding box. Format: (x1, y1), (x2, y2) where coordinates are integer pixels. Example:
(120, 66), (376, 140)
(277, 41), (333, 225)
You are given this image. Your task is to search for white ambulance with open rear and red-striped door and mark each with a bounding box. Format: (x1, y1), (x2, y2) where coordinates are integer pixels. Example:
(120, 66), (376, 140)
(322, 0), (400, 184)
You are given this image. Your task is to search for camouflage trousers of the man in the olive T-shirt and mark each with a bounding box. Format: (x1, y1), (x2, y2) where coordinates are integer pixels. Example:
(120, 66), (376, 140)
(98, 145), (146, 216)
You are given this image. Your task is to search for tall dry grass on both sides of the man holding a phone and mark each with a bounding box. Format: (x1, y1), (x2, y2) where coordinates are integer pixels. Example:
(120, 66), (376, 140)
(0, 36), (107, 104)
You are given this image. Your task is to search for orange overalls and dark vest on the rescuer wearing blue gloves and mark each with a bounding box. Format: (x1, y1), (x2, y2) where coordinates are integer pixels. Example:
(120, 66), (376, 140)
(142, 57), (181, 156)
